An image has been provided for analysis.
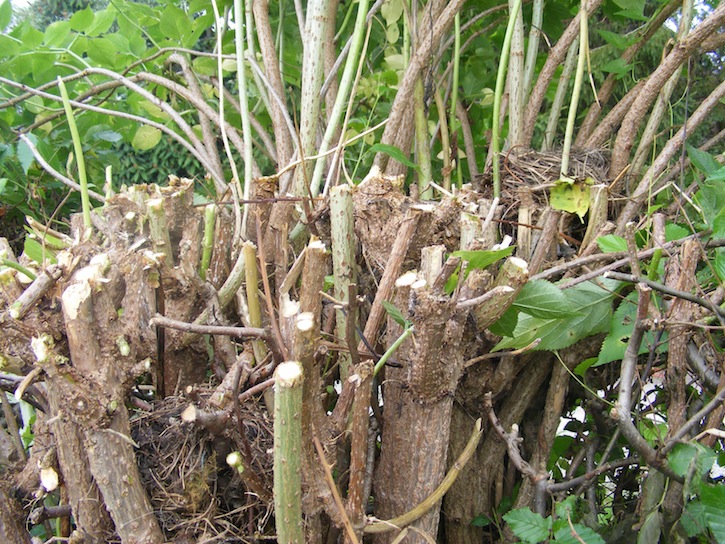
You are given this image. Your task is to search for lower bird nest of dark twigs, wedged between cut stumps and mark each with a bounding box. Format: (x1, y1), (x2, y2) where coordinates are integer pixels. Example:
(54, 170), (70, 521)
(132, 388), (274, 543)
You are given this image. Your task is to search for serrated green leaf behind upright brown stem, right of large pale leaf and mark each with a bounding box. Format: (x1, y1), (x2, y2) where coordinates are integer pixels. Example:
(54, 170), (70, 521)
(594, 291), (667, 366)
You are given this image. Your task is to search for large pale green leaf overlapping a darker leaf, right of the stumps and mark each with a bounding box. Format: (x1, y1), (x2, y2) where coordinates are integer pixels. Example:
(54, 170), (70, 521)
(491, 279), (619, 352)
